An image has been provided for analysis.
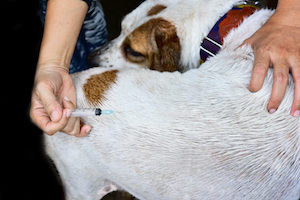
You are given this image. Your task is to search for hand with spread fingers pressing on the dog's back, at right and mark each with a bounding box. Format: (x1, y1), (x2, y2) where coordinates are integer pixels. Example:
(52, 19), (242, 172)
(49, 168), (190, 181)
(244, 0), (300, 117)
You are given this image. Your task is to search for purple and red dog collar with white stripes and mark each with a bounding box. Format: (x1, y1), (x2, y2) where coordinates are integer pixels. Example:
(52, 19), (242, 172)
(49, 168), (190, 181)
(200, 4), (259, 64)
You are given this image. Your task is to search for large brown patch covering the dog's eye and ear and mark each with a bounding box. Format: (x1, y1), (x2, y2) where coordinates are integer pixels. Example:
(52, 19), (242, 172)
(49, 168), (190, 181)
(122, 18), (182, 72)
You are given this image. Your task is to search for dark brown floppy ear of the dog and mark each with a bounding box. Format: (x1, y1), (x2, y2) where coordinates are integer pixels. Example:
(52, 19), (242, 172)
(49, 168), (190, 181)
(150, 18), (182, 72)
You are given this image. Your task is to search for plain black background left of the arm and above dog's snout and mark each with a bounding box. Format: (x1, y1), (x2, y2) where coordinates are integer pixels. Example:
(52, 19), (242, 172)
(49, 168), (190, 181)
(0, 0), (142, 200)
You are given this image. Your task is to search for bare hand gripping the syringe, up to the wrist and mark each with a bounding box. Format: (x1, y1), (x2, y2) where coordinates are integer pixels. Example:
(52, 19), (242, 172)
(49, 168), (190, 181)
(30, 66), (91, 137)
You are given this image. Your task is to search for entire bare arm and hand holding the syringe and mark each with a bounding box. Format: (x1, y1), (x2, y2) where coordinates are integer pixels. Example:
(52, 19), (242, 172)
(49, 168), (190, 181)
(30, 0), (91, 136)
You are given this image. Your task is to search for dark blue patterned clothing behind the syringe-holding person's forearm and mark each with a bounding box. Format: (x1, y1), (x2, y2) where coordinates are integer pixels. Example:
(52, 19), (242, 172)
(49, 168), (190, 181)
(41, 0), (107, 73)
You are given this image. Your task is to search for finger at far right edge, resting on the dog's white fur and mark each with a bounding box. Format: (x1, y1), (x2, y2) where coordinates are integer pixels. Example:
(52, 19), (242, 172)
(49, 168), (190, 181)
(289, 58), (300, 117)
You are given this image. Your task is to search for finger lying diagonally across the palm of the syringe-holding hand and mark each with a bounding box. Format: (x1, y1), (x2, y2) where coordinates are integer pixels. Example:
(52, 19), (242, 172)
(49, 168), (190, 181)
(36, 83), (63, 122)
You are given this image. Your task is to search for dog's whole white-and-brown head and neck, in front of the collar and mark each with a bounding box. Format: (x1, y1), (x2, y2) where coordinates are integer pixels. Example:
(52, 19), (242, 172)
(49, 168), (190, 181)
(88, 0), (241, 72)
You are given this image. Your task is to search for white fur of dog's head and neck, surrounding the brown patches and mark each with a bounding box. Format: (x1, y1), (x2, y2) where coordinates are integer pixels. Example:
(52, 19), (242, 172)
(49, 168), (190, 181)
(100, 0), (242, 71)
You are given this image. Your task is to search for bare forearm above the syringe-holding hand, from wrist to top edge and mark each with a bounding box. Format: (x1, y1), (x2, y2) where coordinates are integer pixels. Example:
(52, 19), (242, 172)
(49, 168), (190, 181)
(38, 0), (88, 70)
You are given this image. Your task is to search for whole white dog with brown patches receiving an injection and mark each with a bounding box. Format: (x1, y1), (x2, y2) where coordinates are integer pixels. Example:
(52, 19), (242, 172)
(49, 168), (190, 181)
(45, 0), (300, 200)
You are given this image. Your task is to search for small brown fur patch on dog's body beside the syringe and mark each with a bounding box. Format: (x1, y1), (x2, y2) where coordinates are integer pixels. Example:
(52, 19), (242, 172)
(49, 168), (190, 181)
(83, 70), (118, 105)
